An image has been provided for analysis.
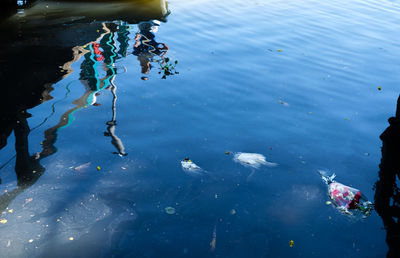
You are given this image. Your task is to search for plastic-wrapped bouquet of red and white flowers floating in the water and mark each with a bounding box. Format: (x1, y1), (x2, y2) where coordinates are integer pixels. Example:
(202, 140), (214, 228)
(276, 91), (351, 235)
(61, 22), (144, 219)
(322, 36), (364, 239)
(318, 170), (373, 217)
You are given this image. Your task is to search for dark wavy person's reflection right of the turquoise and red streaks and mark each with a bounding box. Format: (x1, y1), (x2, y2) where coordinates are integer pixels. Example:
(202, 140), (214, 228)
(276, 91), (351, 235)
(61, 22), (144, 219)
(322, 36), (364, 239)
(133, 20), (169, 80)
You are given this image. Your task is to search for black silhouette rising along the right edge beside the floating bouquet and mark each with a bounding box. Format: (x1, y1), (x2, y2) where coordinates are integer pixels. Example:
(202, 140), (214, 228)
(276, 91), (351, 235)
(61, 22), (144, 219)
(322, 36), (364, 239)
(375, 96), (400, 258)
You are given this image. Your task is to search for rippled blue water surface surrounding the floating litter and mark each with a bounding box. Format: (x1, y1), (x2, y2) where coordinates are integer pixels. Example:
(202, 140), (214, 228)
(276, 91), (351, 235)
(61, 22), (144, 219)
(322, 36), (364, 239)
(0, 0), (400, 257)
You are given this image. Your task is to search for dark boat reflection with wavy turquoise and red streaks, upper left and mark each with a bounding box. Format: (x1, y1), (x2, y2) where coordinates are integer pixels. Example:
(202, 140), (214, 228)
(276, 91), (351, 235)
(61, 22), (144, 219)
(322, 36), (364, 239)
(0, 0), (169, 211)
